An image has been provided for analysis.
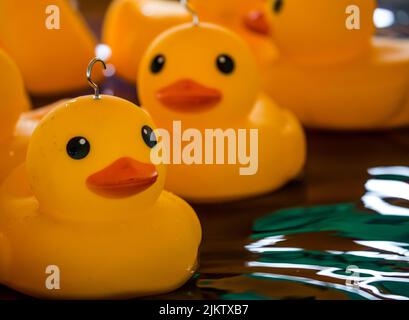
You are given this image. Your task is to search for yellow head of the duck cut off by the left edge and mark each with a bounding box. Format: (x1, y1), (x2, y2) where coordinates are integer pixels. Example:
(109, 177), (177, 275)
(0, 49), (29, 142)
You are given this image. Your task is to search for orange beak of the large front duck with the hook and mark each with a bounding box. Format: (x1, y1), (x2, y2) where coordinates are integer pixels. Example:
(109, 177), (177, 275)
(86, 158), (158, 198)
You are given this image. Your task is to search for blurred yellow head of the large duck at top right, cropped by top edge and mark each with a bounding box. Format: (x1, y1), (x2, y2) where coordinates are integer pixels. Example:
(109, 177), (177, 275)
(267, 0), (376, 63)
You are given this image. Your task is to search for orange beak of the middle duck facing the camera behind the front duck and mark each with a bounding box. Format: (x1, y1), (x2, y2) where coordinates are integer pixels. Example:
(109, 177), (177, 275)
(156, 79), (222, 112)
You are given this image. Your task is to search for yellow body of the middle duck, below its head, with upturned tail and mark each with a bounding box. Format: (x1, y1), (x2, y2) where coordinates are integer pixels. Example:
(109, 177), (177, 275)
(162, 94), (305, 202)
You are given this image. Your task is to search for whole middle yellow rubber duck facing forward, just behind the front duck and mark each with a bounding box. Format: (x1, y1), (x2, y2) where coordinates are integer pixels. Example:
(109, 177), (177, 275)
(138, 23), (305, 202)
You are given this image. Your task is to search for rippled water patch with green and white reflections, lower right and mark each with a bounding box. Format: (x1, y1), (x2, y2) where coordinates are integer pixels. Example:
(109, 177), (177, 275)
(198, 167), (409, 300)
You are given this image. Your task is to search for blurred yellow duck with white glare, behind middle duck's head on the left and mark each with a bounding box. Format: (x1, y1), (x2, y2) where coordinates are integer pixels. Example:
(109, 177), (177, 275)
(102, 0), (190, 83)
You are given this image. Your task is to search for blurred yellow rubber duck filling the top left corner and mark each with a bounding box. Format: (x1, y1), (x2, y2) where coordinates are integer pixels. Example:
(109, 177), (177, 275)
(0, 0), (101, 95)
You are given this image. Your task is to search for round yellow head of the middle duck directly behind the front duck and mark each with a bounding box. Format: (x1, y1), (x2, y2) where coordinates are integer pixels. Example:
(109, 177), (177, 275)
(138, 23), (259, 126)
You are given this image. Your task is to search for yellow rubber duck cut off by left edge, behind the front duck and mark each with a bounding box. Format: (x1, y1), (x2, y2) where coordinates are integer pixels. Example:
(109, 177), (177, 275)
(0, 49), (59, 182)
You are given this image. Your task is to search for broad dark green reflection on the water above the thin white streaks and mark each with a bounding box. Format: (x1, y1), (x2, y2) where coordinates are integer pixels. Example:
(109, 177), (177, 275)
(252, 203), (409, 241)
